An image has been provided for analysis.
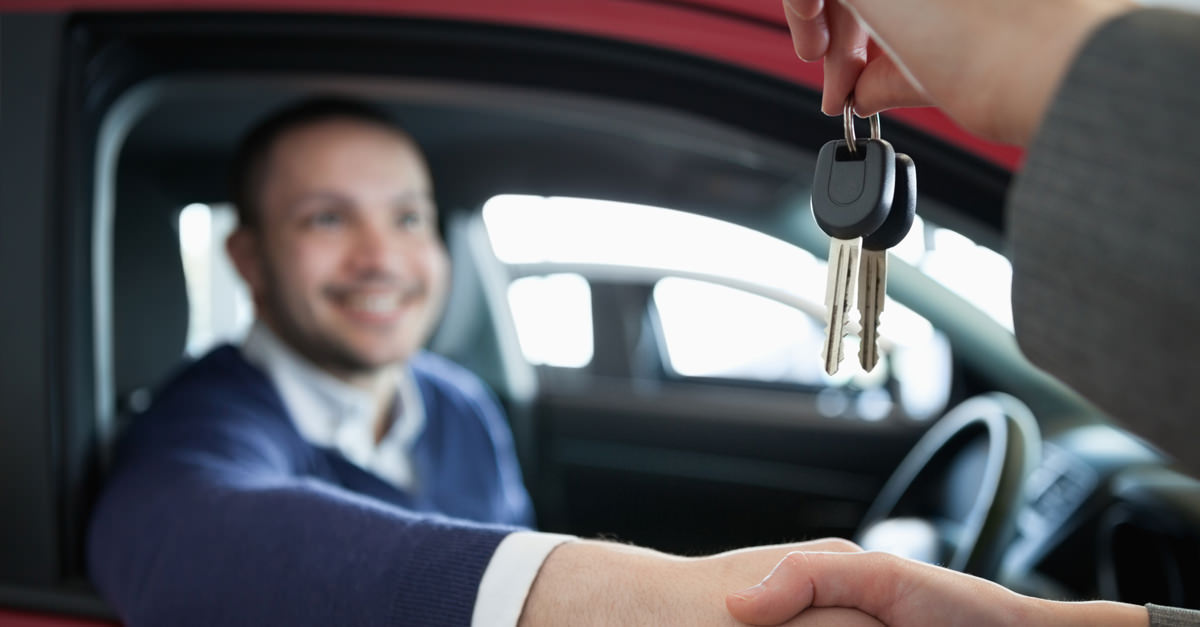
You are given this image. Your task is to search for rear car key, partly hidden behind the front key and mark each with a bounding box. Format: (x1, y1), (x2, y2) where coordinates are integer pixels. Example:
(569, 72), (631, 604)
(858, 153), (917, 372)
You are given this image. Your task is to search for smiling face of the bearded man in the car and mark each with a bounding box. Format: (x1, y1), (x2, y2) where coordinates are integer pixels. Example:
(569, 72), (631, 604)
(230, 119), (449, 377)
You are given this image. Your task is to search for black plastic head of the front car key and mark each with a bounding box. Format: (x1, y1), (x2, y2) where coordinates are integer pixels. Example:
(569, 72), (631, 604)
(812, 139), (896, 239)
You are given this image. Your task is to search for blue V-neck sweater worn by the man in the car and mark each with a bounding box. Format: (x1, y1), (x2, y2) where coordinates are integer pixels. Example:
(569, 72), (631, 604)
(88, 346), (532, 626)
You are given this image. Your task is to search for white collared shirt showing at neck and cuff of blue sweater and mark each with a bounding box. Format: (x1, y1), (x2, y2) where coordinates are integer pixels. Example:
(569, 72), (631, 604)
(241, 321), (575, 627)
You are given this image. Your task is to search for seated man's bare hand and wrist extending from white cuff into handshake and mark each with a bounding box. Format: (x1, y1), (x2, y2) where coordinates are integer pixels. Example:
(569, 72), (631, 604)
(520, 539), (878, 627)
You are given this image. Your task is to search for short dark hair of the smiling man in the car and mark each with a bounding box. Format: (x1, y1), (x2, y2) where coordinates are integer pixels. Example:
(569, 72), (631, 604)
(229, 96), (419, 228)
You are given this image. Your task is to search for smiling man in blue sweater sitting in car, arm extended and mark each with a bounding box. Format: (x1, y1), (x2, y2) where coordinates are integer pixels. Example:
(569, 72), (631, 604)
(88, 100), (874, 626)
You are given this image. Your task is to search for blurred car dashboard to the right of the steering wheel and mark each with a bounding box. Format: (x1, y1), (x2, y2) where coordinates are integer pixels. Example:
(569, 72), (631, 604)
(1001, 425), (1200, 607)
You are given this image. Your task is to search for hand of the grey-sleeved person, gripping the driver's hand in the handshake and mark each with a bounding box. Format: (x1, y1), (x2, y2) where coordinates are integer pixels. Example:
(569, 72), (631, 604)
(726, 551), (1148, 627)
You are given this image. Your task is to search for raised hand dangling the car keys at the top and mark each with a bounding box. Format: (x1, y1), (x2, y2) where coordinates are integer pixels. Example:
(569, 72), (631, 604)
(784, 0), (1134, 145)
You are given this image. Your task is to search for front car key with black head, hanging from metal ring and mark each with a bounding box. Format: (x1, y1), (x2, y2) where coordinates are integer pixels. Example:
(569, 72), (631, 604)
(812, 98), (895, 375)
